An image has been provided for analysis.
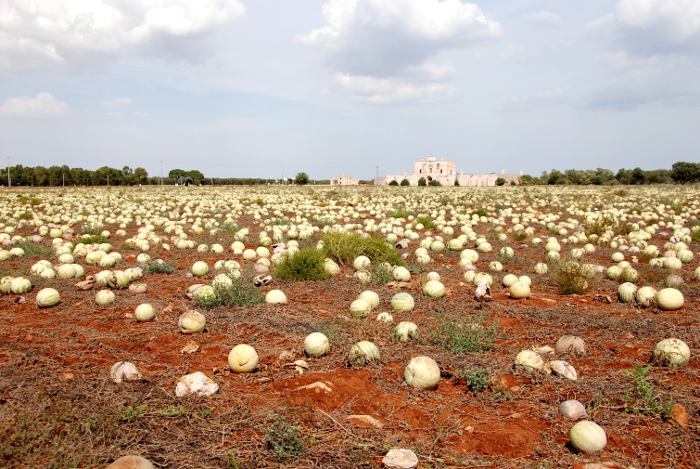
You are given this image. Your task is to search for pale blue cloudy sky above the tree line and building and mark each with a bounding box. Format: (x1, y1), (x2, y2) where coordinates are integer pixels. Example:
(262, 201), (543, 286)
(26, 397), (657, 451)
(0, 0), (700, 179)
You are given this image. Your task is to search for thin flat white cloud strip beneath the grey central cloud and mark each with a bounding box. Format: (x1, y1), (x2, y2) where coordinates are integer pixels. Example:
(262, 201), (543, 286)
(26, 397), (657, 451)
(336, 74), (459, 105)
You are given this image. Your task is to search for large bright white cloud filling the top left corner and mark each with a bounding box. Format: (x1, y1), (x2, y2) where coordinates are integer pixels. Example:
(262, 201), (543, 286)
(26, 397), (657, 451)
(0, 0), (245, 70)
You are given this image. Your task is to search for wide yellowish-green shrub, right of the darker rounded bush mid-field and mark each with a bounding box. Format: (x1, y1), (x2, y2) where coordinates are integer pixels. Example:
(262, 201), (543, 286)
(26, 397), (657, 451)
(323, 232), (404, 265)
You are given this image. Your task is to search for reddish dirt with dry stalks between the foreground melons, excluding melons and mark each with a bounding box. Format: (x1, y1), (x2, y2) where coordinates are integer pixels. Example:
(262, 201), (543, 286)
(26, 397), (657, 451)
(0, 186), (700, 468)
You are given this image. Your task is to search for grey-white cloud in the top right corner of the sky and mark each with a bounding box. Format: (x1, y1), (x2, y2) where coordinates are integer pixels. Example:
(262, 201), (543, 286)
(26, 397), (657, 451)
(588, 0), (700, 109)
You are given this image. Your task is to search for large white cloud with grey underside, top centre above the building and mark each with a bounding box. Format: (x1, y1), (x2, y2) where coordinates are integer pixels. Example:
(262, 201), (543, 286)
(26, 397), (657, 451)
(298, 0), (501, 104)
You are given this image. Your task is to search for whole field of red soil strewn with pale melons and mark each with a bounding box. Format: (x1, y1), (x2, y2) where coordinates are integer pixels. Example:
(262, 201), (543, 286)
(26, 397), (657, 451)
(0, 186), (700, 468)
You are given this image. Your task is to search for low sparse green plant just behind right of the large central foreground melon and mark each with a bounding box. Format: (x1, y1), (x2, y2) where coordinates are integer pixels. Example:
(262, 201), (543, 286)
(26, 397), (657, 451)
(433, 316), (498, 353)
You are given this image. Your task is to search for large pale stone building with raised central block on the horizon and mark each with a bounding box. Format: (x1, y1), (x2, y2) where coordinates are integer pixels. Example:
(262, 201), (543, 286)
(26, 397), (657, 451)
(377, 156), (518, 187)
